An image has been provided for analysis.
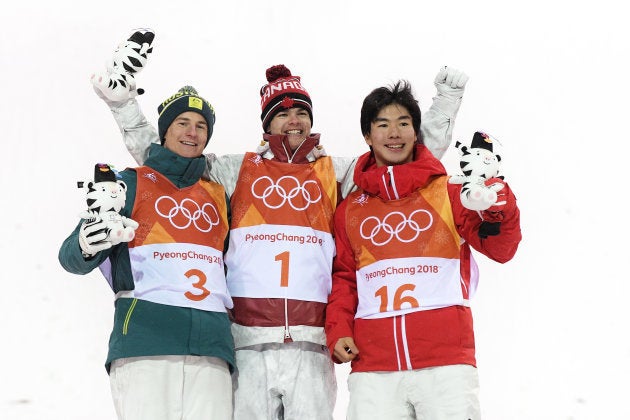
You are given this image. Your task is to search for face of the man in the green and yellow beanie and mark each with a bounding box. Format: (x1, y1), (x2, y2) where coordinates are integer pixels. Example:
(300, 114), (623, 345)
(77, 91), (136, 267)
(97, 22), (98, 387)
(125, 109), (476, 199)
(164, 111), (208, 157)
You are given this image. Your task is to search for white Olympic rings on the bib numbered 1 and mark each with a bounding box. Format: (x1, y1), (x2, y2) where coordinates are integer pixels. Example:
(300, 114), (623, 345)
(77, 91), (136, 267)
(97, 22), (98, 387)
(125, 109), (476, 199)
(252, 175), (322, 211)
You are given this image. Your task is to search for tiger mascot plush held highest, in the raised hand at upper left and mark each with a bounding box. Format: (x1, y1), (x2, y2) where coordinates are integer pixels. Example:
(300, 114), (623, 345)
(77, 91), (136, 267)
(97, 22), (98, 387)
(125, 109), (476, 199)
(91, 29), (155, 102)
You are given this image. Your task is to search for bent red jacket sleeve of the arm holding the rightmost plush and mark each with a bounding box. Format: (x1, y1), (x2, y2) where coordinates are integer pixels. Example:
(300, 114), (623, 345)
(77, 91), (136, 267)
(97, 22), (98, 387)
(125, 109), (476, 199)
(448, 180), (522, 263)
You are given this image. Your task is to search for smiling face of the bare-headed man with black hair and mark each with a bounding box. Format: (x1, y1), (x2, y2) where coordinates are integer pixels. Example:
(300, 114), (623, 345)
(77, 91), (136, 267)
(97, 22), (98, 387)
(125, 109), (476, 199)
(365, 103), (416, 167)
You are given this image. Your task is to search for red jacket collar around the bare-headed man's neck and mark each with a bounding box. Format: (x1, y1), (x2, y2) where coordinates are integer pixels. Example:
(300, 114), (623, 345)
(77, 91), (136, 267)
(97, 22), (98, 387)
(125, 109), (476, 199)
(354, 144), (446, 200)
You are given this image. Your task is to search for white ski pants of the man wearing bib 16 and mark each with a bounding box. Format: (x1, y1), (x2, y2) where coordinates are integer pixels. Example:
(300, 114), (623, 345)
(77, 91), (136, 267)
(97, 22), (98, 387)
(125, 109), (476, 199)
(347, 365), (481, 420)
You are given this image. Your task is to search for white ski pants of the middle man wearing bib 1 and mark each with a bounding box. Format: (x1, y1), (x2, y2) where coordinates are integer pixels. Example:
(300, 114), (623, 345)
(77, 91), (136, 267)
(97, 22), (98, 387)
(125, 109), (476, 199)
(234, 341), (337, 420)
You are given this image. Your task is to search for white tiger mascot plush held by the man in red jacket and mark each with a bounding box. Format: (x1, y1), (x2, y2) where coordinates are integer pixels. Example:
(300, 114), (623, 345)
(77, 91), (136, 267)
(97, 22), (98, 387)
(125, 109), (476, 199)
(449, 131), (505, 211)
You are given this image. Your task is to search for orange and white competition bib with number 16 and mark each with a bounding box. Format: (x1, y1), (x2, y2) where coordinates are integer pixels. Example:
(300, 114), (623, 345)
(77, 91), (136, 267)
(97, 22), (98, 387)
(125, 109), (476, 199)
(346, 177), (470, 318)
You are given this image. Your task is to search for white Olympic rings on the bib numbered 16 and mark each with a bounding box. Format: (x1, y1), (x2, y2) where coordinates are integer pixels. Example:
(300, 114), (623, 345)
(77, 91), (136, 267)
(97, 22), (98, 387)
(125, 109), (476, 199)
(359, 209), (433, 246)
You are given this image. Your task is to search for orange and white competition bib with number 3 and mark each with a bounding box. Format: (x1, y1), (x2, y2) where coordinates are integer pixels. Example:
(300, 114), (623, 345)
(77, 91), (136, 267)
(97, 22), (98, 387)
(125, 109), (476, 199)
(123, 167), (233, 312)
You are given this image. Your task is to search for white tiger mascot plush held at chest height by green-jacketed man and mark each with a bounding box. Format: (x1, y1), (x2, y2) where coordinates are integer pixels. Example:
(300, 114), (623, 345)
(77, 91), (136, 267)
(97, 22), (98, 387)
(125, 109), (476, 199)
(77, 163), (138, 246)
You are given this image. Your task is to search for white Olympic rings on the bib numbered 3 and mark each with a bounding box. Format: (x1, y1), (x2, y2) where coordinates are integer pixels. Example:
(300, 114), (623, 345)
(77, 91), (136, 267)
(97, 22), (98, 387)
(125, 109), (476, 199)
(155, 195), (220, 232)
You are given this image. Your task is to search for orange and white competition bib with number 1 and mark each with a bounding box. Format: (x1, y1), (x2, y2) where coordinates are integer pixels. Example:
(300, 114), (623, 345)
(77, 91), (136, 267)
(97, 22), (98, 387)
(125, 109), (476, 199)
(225, 154), (337, 303)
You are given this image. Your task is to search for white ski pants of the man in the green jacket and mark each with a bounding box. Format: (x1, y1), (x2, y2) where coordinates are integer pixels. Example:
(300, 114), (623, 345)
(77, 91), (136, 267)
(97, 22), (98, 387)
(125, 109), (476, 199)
(109, 356), (232, 420)
